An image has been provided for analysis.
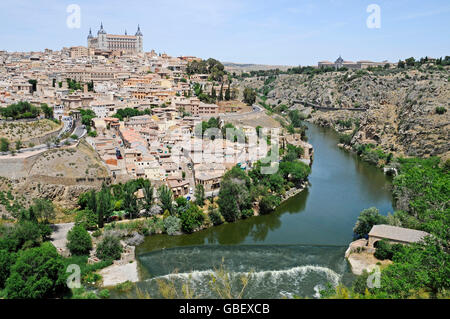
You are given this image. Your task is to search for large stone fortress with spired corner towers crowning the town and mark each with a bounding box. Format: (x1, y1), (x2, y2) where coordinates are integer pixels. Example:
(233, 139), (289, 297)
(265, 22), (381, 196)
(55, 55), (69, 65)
(87, 23), (144, 54)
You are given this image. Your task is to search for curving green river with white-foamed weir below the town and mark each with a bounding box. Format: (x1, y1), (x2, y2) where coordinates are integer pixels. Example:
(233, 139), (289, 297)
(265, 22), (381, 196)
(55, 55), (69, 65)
(115, 124), (393, 298)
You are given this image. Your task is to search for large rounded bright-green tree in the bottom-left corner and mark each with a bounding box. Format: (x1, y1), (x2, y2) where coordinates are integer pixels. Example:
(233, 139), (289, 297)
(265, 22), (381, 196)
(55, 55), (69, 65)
(5, 242), (67, 299)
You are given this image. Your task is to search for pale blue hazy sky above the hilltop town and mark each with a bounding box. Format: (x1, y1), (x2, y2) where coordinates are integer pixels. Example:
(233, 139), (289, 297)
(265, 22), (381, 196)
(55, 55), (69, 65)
(0, 0), (450, 66)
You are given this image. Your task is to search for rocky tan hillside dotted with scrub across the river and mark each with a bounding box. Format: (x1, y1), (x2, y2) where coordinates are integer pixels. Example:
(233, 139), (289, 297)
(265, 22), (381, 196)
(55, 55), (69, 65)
(239, 67), (450, 159)
